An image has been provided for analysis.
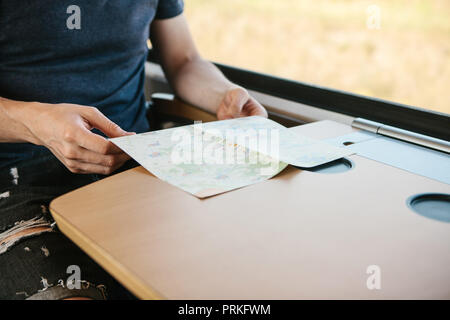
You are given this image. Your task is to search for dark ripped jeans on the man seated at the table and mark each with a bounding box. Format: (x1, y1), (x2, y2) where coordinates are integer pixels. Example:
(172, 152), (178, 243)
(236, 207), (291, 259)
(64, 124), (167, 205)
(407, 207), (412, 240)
(0, 152), (137, 300)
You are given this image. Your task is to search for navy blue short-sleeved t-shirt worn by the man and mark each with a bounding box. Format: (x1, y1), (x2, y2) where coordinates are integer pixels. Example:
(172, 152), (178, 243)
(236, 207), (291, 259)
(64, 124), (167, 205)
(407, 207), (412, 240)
(0, 0), (183, 167)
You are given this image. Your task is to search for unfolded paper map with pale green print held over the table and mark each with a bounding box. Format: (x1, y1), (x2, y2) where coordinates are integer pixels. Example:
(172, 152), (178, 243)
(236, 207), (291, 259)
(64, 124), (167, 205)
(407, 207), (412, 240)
(110, 117), (352, 198)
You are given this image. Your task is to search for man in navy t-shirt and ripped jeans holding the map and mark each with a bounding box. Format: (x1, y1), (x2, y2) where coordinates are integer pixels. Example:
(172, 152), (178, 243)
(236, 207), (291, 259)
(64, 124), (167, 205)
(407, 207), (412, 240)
(0, 0), (267, 299)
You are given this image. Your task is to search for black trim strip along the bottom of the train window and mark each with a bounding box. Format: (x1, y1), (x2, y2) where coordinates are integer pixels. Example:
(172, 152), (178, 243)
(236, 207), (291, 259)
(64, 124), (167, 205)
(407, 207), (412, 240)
(148, 50), (450, 141)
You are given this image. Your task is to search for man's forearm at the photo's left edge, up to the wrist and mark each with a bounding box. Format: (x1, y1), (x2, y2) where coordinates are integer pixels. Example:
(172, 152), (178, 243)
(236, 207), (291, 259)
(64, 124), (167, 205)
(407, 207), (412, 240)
(0, 97), (39, 142)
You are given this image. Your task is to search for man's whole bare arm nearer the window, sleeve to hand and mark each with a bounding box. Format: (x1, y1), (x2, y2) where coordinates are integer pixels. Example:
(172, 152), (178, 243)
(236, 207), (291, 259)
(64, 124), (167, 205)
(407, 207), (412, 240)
(151, 15), (267, 119)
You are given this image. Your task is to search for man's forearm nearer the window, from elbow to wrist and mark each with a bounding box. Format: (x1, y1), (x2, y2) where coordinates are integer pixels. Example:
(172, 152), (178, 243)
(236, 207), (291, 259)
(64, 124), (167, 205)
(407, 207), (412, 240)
(169, 57), (238, 113)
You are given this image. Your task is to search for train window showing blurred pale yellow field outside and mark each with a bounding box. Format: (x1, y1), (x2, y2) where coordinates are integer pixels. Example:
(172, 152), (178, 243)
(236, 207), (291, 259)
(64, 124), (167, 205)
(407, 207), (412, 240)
(185, 0), (450, 113)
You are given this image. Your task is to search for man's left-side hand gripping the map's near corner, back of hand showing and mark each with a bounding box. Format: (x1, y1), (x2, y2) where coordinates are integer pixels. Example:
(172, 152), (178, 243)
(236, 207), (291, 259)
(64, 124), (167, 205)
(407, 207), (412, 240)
(25, 103), (134, 174)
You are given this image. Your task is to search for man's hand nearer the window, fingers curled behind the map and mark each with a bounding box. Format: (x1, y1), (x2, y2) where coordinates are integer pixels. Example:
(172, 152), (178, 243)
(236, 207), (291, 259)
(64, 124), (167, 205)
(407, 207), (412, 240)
(217, 87), (267, 120)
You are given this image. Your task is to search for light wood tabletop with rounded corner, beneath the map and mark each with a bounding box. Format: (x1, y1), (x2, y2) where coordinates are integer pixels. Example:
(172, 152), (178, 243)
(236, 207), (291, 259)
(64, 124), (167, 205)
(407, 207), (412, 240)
(50, 121), (450, 299)
